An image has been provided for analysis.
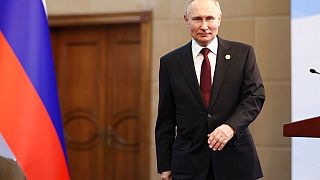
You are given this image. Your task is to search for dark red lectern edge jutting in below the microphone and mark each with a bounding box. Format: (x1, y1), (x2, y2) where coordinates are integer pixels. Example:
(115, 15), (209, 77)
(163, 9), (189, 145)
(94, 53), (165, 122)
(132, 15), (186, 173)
(283, 116), (320, 138)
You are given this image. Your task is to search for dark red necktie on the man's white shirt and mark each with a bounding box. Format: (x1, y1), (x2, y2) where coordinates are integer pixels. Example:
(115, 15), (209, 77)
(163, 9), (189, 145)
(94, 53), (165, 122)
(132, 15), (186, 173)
(200, 48), (211, 107)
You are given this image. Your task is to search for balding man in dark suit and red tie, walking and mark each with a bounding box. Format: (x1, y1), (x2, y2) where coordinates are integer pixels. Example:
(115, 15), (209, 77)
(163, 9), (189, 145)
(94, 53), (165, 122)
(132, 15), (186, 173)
(155, 0), (265, 180)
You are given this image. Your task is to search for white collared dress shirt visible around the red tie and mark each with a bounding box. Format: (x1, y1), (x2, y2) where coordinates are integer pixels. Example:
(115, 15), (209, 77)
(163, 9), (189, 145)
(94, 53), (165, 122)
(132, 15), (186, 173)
(191, 36), (218, 85)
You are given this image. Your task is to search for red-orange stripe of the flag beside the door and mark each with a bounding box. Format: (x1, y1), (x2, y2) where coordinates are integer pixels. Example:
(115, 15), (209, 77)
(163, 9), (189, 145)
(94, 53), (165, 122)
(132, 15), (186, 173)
(0, 31), (69, 180)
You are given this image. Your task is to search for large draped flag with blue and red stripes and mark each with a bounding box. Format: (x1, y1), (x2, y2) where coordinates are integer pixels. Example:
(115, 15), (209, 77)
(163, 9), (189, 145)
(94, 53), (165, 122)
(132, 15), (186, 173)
(0, 0), (70, 180)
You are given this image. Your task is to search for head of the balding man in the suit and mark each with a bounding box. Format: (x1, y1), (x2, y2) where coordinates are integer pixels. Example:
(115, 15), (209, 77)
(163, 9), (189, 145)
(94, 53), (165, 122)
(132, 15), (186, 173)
(184, 0), (221, 46)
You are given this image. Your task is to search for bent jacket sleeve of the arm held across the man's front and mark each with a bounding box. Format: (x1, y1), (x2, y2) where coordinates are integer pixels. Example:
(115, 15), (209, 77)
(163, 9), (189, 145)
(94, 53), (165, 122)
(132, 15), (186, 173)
(222, 46), (265, 138)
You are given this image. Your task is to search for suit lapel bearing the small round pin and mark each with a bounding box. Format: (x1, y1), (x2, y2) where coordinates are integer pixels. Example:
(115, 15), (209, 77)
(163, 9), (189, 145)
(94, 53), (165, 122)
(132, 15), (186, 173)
(209, 38), (233, 109)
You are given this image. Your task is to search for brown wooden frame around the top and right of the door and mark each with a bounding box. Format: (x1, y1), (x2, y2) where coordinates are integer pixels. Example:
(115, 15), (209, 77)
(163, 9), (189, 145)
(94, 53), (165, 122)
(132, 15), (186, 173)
(48, 11), (152, 180)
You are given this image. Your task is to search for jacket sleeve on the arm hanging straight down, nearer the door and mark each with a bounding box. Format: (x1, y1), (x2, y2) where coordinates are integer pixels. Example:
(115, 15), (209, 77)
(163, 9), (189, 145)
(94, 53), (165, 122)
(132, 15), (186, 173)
(155, 58), (176, 173)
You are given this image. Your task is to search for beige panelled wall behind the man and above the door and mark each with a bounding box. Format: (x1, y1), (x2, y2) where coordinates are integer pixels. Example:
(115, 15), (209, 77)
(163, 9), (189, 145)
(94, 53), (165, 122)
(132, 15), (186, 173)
(46, 0), (291, 180)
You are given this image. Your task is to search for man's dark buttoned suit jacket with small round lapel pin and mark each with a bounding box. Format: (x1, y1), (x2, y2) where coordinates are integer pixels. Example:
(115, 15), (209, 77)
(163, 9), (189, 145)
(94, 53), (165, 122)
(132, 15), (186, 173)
(155, 38), (265, 180)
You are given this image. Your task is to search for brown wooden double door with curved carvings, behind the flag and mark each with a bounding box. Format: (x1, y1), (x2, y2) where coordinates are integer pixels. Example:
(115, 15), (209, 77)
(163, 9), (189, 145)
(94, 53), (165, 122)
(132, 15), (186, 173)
(51, 13), (150, 180)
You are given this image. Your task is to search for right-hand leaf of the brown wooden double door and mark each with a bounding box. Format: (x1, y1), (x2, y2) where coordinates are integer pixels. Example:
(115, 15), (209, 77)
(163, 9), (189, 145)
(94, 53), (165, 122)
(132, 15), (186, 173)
(106, 25), (142, 179)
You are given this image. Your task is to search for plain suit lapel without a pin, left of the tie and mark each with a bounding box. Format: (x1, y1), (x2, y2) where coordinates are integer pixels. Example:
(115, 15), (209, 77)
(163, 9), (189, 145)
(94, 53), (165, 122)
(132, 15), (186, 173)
(179, 42), (206, 109)
